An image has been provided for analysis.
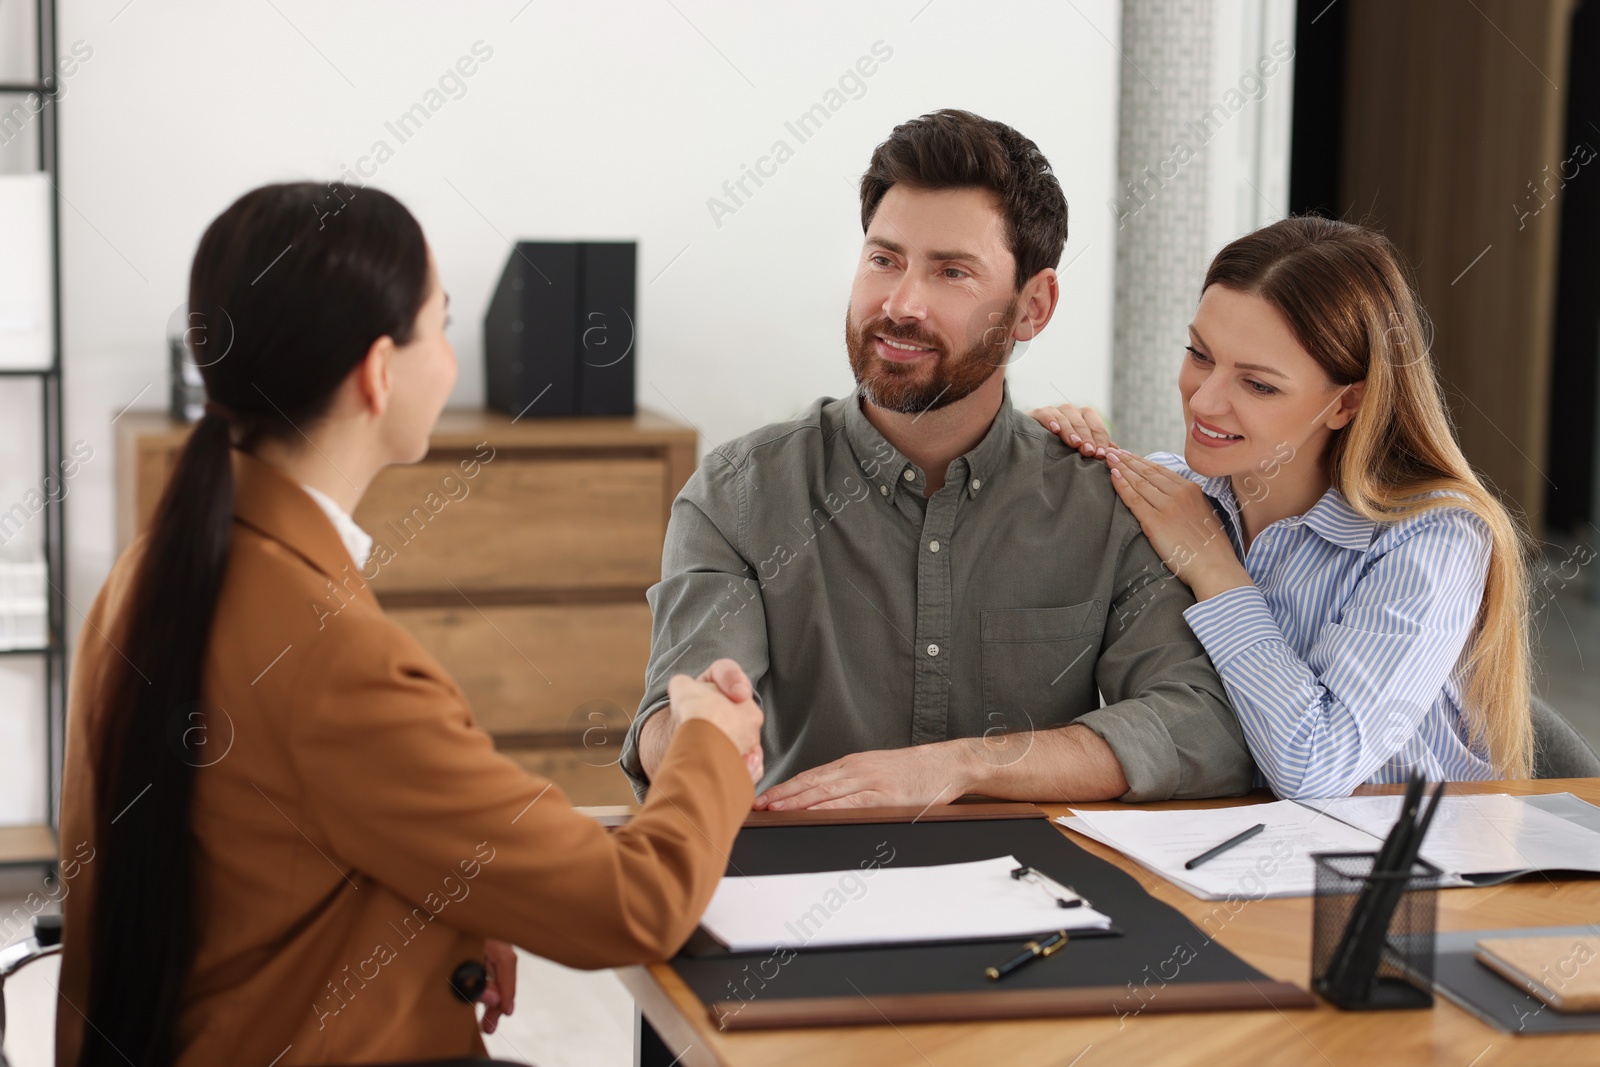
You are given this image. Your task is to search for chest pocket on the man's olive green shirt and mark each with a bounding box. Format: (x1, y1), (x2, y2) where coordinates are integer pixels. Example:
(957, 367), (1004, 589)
(979, 600), (1106, 737)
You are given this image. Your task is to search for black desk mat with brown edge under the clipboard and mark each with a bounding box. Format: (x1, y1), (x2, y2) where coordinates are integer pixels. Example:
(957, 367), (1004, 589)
(672, 817), (1315, 1029)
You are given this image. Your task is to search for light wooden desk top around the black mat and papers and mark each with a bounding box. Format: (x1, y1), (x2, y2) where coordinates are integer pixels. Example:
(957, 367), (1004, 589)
(618, 779), (1600, 1067)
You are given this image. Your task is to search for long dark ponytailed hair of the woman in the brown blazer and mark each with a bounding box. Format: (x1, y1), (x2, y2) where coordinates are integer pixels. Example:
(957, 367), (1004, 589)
(79, 182), (430, 1067)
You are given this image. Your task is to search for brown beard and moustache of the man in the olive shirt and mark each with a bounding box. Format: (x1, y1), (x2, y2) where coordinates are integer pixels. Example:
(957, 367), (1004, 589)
(845, 298), (1018, 414)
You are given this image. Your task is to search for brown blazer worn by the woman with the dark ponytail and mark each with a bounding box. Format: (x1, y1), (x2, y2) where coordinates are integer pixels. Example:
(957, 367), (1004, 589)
(56, 453), (752, 1067)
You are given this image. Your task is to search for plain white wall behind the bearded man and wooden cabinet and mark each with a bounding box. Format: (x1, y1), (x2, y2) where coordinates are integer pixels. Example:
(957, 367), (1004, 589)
(0, 0), (1120, 822)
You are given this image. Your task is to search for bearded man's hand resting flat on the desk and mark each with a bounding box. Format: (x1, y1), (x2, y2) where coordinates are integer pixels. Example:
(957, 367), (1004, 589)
(755, 744), (968, 811)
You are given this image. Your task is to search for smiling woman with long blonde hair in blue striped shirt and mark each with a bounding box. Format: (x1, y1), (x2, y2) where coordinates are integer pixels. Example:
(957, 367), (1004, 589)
(1032, 218), (1533, 797)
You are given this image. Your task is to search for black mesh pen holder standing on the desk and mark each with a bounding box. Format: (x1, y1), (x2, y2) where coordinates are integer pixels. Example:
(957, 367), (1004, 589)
(1310, 853), (1440, 1011)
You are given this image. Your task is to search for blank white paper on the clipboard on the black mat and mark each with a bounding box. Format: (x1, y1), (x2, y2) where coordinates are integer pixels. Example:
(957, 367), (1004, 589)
(701, 856), (1110, 952)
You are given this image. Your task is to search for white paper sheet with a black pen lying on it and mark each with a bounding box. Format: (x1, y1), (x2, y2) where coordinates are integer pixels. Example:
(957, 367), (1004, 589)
(1058, 800), (1376, 901)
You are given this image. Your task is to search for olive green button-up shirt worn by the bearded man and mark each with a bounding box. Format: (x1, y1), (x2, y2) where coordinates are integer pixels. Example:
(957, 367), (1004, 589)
(622, 390), (1253, 800)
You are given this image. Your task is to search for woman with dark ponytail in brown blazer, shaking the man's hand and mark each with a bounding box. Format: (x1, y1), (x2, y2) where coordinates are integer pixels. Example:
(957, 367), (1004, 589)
(58, 182), (760, 1067)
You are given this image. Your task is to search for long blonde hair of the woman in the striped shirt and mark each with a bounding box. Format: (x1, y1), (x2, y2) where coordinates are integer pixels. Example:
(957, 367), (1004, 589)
(1205, 218), (1533, 777)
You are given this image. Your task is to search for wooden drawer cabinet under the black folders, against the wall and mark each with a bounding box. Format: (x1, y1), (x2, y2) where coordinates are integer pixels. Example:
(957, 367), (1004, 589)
(117, 411), (696, 805)
